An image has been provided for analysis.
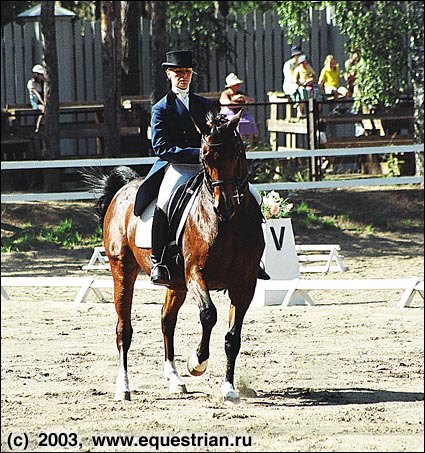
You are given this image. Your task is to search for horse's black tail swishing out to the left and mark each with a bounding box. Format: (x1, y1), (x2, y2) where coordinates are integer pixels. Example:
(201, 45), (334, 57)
(82, 166), (140, 226)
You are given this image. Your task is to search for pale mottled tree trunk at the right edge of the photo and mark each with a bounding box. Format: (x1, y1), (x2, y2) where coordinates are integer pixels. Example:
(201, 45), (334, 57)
(408, 1), (424, 176)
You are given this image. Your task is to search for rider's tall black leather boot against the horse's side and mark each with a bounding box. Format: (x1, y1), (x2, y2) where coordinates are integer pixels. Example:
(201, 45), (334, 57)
(151, 207), (170, 286)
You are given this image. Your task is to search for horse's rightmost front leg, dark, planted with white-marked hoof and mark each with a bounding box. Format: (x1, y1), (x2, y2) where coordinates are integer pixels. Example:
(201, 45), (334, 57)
(221, 287), (255, 404)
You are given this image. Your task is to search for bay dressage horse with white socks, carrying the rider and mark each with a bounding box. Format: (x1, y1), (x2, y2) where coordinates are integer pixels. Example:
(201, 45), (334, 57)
(92, 114), (264, 403)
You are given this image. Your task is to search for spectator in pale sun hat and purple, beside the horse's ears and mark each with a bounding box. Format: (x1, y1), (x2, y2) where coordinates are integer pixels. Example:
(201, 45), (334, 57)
(220, 72), (258, 140)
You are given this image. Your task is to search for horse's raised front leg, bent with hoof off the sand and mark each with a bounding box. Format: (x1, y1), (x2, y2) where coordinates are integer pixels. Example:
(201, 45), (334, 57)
(187, 278), (217, 376)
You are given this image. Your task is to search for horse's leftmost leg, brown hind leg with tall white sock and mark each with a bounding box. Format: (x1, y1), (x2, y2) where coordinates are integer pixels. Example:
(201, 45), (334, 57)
(110, 259), (140, 401)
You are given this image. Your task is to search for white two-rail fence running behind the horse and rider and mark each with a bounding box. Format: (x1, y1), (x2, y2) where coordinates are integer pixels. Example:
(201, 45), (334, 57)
(1, 145), (424, 203)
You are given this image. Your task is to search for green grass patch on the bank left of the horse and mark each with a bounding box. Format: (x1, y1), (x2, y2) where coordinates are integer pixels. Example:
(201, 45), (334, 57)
(1, 219), (102, 253)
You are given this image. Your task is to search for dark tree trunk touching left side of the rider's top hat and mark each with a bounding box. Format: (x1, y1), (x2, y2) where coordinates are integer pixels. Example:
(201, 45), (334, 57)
(151, 1), (167, 104)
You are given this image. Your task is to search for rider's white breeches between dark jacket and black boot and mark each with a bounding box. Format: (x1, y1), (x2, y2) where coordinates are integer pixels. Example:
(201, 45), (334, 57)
(156, 164), (261, 213)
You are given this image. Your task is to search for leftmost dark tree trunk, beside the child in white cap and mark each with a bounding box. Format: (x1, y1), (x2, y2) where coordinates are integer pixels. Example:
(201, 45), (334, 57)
(40, 1), (61, 192)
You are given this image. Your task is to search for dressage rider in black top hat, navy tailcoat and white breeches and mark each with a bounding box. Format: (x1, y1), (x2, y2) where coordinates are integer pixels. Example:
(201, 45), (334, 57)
(134, 50), (270, 285)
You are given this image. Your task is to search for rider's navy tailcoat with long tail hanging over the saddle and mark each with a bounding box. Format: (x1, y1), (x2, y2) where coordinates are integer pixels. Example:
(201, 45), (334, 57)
(134, 91), (211, 216)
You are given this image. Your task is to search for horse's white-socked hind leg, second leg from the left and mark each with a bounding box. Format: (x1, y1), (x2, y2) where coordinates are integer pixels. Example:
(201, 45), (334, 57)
(161, 289), (187, 393)
